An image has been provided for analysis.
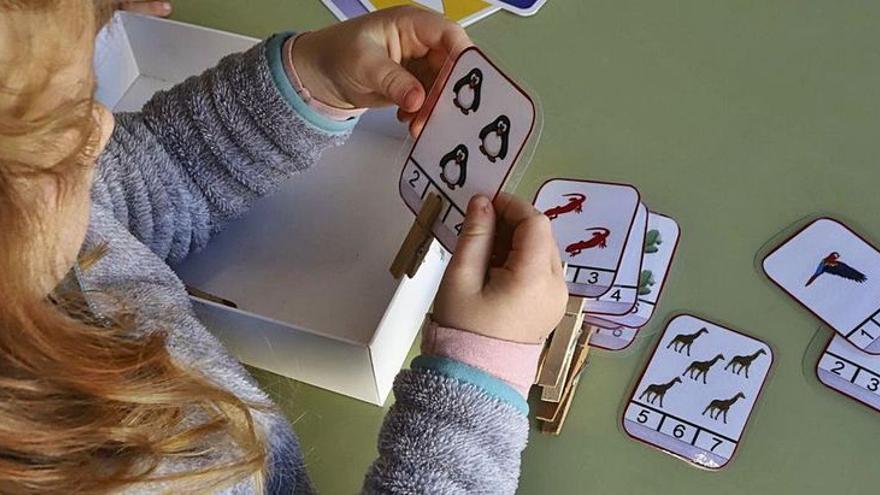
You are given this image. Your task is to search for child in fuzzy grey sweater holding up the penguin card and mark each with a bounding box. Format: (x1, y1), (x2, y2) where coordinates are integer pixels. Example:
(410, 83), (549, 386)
(0, 0), (566, 494)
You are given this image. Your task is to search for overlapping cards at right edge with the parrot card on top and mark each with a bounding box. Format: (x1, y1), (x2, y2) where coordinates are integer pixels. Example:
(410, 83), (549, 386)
(763, 218), (880, 411)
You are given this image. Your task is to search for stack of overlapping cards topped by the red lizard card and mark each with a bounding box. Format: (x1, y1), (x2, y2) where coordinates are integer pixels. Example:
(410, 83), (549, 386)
(534, 179), (679, 351)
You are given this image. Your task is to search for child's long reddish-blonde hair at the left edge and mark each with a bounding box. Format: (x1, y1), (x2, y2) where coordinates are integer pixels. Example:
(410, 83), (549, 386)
(0, 0), (267, 493)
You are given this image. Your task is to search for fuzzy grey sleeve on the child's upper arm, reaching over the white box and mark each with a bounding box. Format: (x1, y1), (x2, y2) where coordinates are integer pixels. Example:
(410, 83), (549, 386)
(92, 35), (356, 263)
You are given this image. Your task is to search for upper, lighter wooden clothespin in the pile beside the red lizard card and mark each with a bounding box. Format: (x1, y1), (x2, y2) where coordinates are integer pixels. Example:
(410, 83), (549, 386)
(537, 296), (585, 402)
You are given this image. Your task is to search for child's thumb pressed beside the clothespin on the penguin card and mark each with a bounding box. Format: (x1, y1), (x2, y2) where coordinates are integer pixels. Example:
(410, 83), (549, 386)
(446, 195), (495, 293)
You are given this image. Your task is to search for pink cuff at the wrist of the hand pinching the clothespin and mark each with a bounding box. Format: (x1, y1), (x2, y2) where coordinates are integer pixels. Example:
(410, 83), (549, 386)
(422, 321), (544, 398)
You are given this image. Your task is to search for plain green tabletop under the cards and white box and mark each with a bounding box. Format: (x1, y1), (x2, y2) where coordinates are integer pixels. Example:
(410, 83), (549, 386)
(173, 0), (880, 495)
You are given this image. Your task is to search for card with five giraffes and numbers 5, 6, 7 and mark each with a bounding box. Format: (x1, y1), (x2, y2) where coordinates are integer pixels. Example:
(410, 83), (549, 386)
(623, 315), (773, 469)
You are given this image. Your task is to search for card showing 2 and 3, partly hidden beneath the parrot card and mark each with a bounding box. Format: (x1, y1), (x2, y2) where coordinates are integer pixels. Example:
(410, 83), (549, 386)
(816, 335), (880, 412)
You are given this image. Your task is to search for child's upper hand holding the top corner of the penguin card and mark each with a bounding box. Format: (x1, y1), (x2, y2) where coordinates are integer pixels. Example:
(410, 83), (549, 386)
(293, 7), (471, 136)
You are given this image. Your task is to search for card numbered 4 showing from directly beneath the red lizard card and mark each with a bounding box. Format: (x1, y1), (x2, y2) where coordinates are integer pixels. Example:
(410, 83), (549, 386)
(585, 204), (648, 315)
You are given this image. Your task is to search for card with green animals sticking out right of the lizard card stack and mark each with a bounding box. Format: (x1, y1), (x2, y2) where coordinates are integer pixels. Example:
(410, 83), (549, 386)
(584, 212), (680, 328)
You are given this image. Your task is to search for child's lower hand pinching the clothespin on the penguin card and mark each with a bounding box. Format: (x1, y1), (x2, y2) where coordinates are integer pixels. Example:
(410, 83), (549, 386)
(434, 195), (568, 343)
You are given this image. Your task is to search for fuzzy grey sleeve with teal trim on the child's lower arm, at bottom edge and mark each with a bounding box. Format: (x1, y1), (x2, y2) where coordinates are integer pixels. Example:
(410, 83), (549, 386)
(363, 356), (529, 494)
